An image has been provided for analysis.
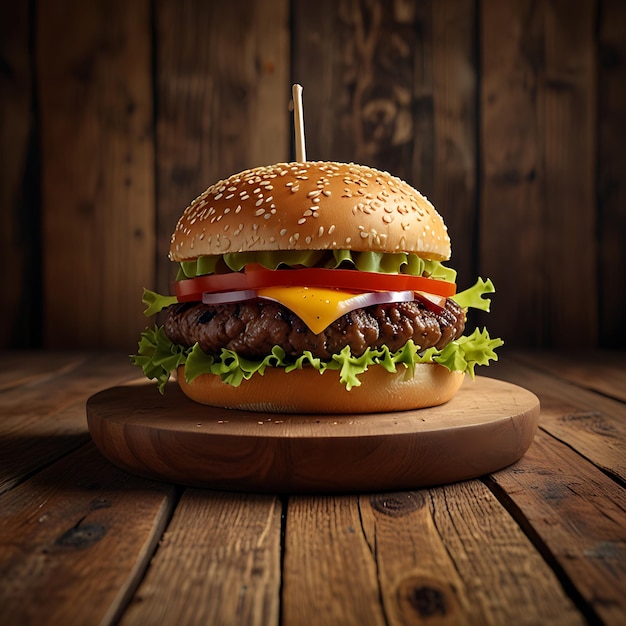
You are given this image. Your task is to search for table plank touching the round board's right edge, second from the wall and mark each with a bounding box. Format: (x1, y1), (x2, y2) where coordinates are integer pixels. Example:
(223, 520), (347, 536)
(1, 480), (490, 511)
(489, 359), (626, 483)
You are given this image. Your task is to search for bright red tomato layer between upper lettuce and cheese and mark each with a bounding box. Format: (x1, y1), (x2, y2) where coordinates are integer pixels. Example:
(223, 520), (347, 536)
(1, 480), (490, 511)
(174, 265), (456, 302)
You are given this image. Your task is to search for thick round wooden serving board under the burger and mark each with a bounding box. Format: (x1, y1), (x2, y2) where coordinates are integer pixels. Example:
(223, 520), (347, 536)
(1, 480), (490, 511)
(87, 377), (539, 493)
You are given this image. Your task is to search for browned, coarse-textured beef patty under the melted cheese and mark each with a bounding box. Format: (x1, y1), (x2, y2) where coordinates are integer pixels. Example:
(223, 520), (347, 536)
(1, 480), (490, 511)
(164, 299), (465, 359)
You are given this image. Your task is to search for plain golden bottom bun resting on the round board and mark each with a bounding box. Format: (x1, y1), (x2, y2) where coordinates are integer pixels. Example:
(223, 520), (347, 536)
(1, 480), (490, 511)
(178, 363), (464, 414)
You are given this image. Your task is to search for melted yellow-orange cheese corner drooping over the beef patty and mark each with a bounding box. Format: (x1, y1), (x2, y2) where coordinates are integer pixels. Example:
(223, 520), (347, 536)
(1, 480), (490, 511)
(258, 287), (362, 335)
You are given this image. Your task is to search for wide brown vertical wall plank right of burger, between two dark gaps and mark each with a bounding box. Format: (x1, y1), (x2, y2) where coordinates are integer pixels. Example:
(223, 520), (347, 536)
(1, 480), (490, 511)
(480, 0), (599, 348)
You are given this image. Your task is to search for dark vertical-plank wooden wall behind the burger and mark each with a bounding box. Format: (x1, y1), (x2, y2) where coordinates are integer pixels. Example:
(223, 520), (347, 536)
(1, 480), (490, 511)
(0, 0), (626, 351)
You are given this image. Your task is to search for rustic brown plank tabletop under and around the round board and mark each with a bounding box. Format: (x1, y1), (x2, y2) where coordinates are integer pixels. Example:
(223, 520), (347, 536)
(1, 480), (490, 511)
(0, 351), (626, 626)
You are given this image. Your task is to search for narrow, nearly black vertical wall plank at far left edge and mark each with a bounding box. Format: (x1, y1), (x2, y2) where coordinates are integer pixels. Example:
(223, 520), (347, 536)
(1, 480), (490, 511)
(0, 0), (40, 348)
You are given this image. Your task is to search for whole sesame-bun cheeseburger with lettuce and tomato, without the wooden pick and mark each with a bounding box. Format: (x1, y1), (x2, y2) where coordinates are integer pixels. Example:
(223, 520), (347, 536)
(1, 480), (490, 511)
(131, 161), (503, 413)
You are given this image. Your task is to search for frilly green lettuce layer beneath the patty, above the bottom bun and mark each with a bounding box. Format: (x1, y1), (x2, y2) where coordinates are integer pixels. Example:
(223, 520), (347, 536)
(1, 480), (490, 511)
(131, 326), (503, 393)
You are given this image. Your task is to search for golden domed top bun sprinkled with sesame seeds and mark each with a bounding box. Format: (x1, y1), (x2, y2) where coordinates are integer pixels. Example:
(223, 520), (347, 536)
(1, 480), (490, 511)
(170, 161), (450, 262)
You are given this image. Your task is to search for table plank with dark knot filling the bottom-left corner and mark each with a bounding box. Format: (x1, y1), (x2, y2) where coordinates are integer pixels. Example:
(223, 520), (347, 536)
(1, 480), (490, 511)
(0, 445), (174, 625)
